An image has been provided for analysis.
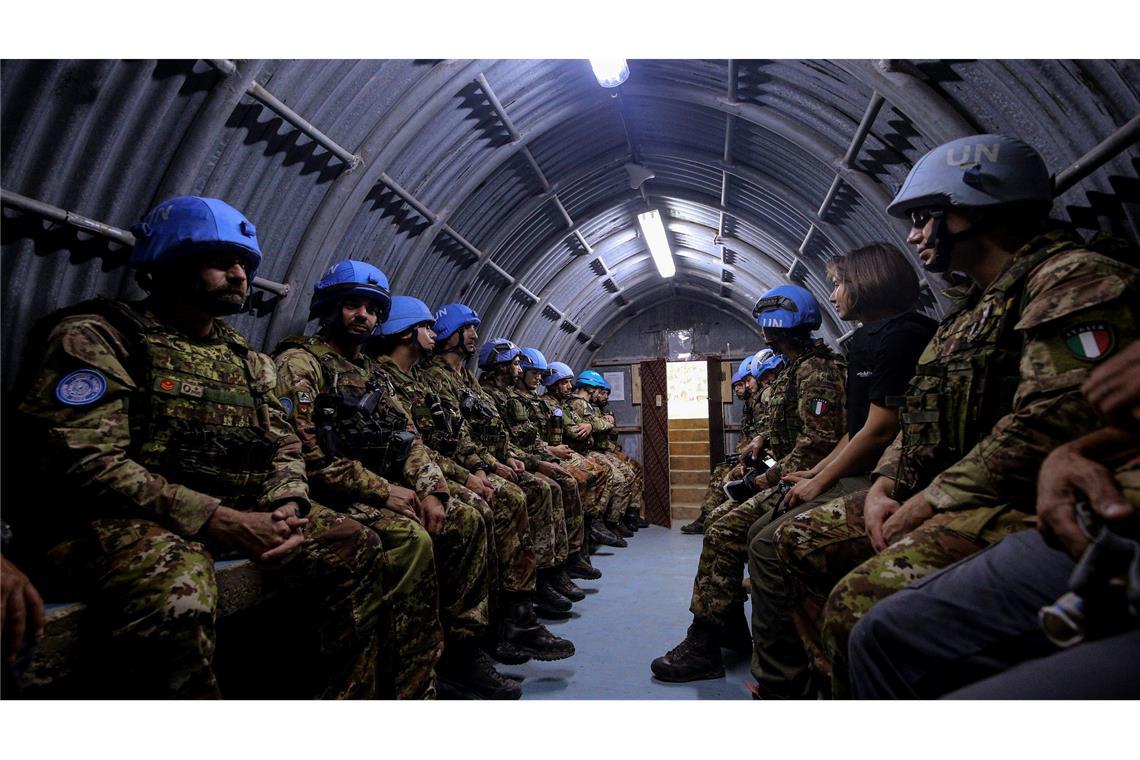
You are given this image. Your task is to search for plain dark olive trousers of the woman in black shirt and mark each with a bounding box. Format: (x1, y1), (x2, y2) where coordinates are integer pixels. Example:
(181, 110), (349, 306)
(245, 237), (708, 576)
(748, 475), (871, 698)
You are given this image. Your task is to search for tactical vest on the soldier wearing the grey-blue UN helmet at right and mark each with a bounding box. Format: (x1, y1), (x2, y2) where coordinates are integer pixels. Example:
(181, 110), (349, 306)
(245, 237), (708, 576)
(886, 233), (1085, 492)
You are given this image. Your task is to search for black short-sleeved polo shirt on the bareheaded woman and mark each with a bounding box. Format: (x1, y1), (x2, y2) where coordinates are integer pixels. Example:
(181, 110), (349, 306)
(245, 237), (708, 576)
(847, 311), (938, 438)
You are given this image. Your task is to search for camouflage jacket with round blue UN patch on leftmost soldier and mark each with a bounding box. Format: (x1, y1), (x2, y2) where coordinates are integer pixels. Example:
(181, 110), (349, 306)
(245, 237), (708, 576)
(19, 299), (309, 537)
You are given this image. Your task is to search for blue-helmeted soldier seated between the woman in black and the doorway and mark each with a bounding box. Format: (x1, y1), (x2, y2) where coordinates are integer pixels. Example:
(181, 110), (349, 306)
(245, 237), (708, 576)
(651, 285), (846, 681)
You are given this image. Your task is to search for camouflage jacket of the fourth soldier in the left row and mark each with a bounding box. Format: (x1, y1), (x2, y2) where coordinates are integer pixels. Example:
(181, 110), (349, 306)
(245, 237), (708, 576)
(424, 354), (511, 471)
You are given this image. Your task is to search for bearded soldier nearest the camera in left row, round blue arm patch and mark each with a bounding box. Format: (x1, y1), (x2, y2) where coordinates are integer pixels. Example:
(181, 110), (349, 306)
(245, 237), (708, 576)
(11, 196), (396, 698)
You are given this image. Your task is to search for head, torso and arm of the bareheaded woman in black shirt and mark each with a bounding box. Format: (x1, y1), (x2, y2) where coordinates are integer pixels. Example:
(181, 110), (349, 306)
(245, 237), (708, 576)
(783, 243), (937, 508)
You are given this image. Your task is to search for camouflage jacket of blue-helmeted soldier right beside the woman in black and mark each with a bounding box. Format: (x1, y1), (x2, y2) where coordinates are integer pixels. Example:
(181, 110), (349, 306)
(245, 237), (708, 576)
(760, 340), (847, 482)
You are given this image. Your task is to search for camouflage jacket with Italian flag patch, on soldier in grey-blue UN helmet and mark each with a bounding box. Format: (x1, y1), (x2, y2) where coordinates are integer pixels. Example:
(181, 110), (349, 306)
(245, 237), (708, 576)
(876, 231), (1140, 533)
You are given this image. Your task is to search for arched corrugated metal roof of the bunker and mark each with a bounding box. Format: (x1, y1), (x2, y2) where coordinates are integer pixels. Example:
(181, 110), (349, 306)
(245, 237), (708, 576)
(0, 60), (1140, 382)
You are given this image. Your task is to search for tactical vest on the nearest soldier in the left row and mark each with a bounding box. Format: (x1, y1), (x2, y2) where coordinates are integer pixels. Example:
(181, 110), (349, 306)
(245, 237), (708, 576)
(57, 299), (278, 508)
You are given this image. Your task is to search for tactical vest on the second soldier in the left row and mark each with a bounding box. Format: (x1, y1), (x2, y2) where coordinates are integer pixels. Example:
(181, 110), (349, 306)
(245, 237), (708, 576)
(277, 335), (416, 480)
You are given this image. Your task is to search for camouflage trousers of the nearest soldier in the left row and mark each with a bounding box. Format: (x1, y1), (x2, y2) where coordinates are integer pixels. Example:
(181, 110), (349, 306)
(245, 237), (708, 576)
(75, 505), (391, 698)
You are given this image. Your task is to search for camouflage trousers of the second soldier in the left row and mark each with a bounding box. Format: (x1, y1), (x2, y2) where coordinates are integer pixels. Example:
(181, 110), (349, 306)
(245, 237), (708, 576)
(344, 504), (442, 700)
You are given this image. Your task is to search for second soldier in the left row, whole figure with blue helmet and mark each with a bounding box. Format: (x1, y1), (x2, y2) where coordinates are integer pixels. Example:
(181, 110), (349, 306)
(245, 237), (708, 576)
(275, 261), (522, 698)
